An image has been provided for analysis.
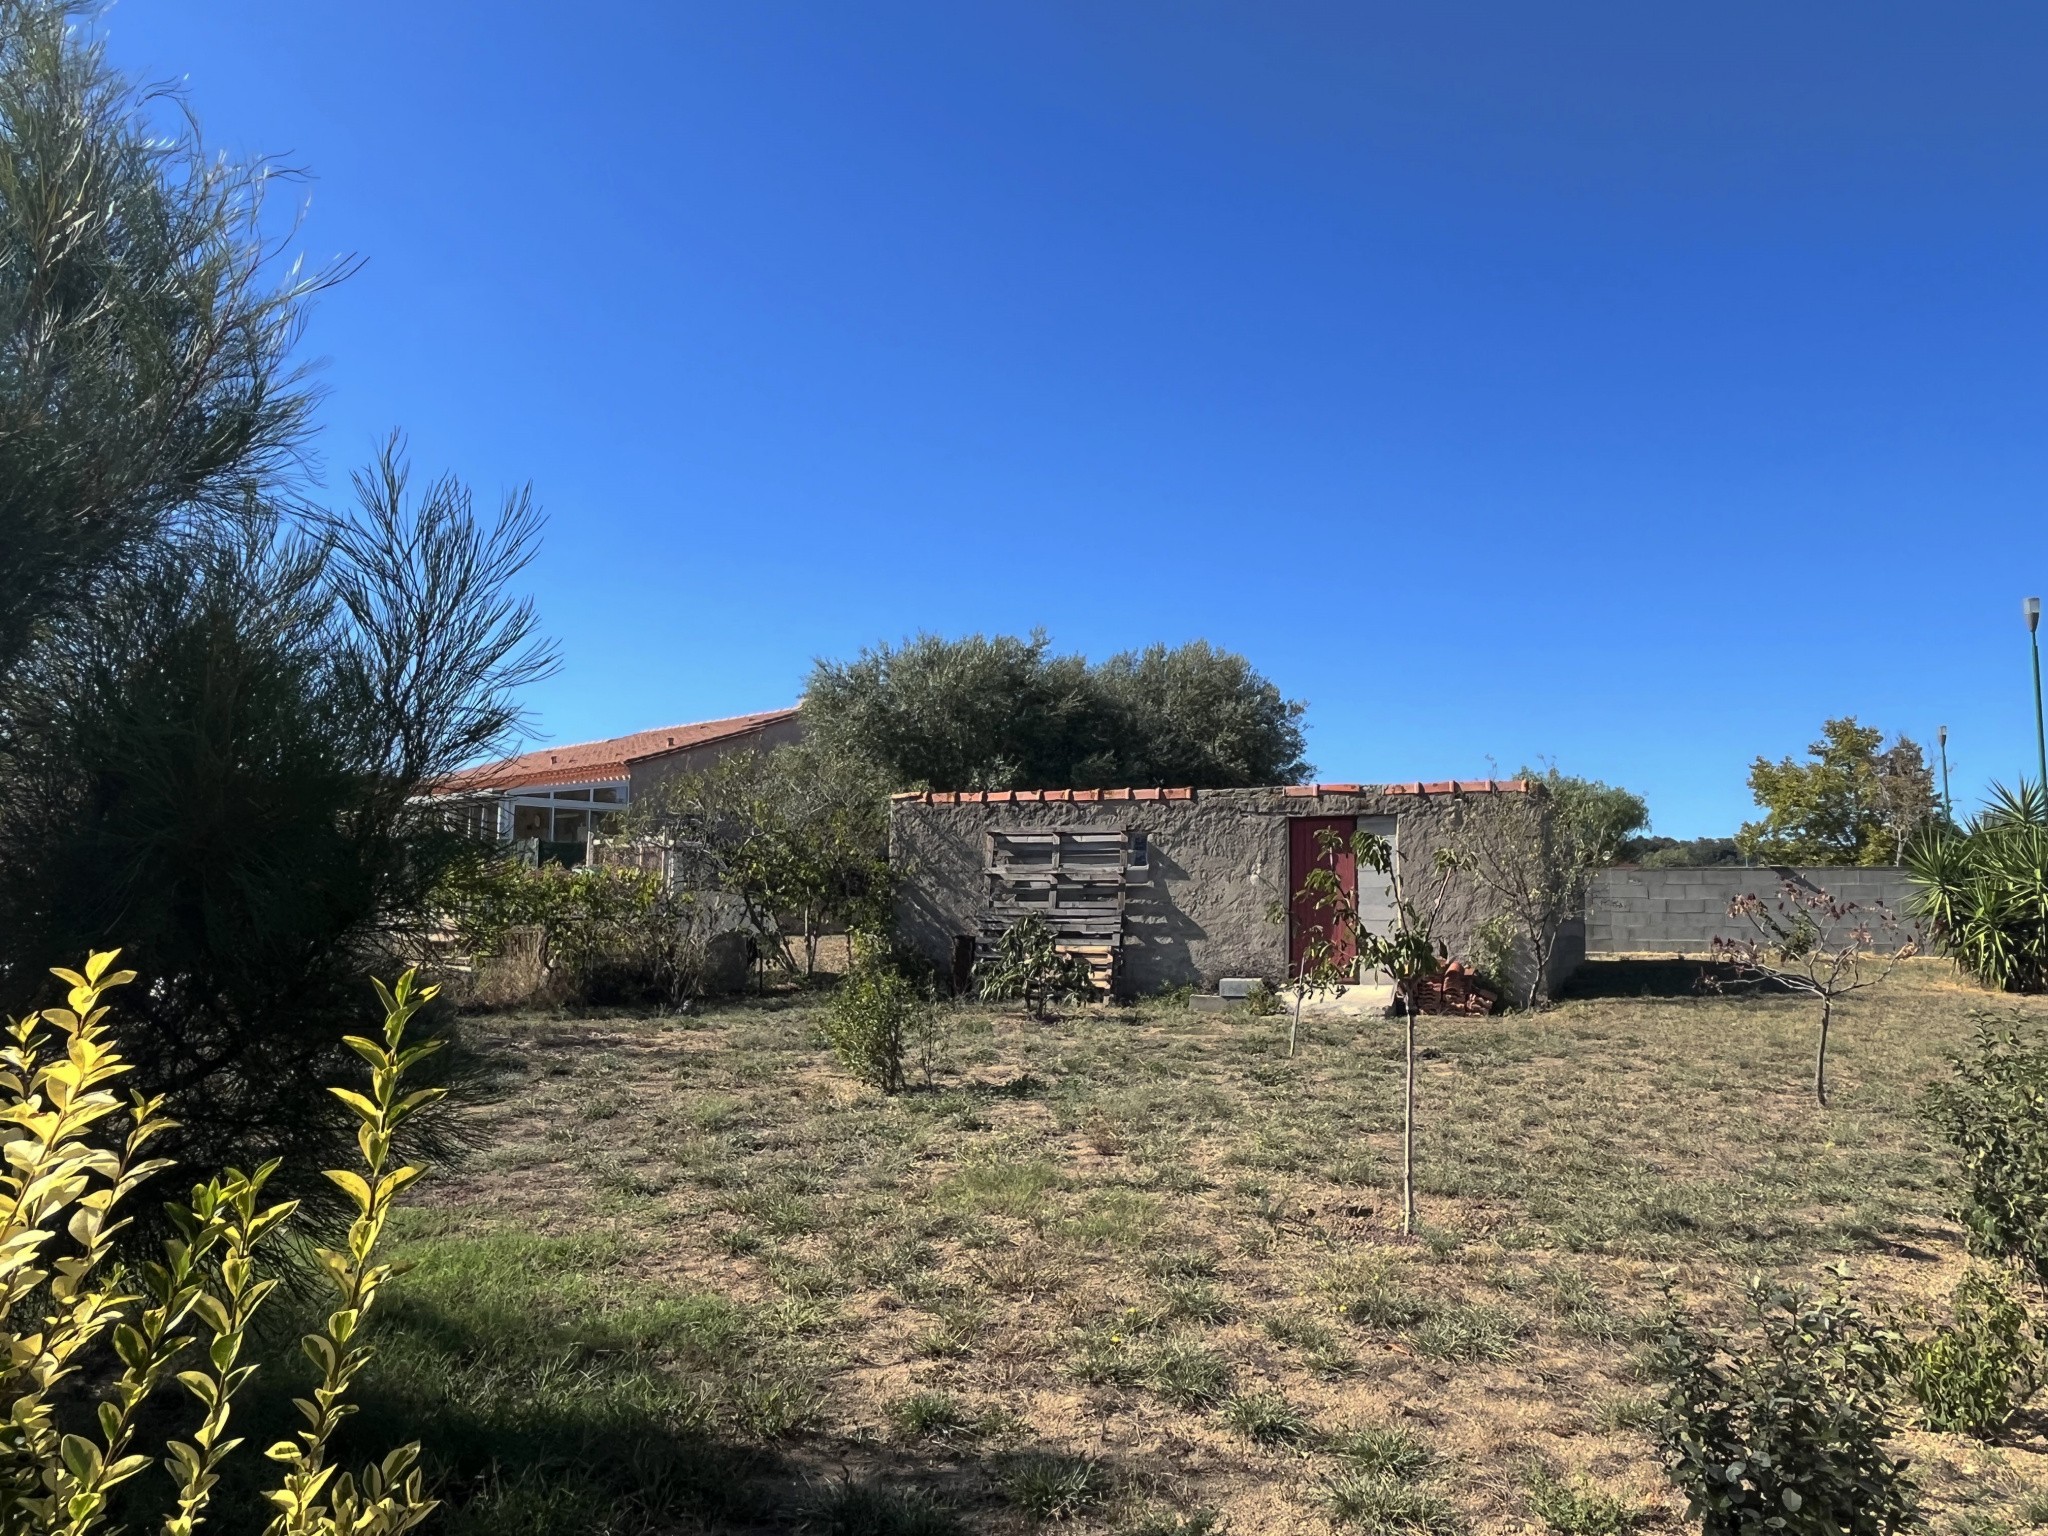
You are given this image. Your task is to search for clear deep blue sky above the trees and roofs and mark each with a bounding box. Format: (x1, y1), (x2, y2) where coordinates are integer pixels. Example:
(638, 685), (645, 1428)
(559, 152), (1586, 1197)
(106, 0), (2048, 836)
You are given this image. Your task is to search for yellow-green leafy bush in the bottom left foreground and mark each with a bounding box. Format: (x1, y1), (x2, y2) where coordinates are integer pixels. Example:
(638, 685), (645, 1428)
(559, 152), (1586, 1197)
(0, 950), (444, 1536)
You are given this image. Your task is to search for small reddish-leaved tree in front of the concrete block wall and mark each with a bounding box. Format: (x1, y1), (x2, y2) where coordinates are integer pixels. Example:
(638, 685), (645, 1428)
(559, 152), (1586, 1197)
(1714, 881), (1915, 1108)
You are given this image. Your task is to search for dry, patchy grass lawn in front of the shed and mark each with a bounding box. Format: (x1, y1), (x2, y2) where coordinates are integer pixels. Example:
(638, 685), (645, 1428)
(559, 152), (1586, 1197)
(348, 963), (2048, 1536)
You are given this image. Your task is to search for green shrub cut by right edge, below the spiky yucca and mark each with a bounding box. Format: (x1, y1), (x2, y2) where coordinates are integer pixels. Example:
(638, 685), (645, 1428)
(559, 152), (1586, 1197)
(1927, 1018), (2048, 1286)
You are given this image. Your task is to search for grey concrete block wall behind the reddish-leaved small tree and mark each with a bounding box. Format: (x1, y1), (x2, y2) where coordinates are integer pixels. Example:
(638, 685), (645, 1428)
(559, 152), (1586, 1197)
(1585, 864), (1927, 954)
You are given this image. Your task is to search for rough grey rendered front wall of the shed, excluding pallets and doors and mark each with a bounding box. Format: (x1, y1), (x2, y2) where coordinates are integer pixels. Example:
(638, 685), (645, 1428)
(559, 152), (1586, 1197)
(889, 788), (1536, 993)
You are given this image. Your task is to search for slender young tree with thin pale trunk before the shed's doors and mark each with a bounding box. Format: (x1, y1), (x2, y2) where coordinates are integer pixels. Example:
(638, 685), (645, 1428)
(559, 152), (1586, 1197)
(1300, 829), (1458, 1233)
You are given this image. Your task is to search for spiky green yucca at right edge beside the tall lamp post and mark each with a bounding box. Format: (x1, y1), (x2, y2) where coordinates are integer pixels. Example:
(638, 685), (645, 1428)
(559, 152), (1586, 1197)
(1907, 780), (2048, 991)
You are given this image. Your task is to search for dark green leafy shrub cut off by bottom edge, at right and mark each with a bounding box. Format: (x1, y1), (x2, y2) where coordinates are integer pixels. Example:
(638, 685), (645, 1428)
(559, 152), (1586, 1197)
(1659, 1276), (1917, 1536)
